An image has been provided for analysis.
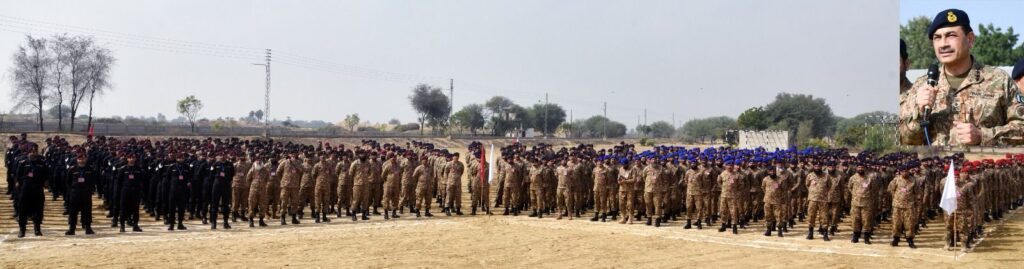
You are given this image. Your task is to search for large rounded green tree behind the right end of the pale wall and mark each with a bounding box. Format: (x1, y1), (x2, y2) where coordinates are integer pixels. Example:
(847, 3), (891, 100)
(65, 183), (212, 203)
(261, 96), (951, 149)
(764, 92), (836, 143)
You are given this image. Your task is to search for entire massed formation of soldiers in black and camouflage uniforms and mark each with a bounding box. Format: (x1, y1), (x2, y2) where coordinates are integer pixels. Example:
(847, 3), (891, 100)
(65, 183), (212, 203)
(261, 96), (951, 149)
(5, 135), (1024, 249)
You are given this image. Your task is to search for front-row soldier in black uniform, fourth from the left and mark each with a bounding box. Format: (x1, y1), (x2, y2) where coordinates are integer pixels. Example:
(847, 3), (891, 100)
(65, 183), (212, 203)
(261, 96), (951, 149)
(165, 153), (192, 231)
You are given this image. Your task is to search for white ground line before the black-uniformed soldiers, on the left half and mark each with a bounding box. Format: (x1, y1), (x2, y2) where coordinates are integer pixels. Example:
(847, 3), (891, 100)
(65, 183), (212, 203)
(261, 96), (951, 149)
(7, 220), (462, 251)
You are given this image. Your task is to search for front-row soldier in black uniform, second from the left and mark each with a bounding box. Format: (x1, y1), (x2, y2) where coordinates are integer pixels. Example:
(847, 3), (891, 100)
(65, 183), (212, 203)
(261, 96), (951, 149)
(65, 153), (97, 235)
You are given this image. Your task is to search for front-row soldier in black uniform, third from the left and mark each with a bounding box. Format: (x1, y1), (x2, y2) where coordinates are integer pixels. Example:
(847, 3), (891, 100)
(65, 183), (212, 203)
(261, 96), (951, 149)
(117, 153), (150, 232)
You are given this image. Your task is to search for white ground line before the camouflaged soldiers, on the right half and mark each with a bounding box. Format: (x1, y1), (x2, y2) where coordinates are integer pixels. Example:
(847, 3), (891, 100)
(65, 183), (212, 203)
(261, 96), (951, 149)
(503, 220), (966, 260)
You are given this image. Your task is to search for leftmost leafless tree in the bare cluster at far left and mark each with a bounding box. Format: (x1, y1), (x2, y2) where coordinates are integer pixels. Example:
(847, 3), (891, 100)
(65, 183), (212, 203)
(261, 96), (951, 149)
(11, 36), (53, 132)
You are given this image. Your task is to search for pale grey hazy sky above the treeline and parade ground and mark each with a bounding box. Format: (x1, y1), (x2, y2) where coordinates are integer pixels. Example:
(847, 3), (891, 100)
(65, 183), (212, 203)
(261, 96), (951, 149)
(0, 0), (897, 127)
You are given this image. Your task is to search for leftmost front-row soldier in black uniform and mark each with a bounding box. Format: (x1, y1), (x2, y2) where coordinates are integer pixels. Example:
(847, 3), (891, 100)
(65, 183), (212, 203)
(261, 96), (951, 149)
(14, 142), (50, 237)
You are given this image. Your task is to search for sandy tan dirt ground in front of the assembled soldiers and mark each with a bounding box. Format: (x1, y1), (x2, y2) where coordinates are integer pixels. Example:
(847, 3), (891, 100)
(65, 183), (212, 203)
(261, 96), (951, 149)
(0, 136), (1024, 268)
